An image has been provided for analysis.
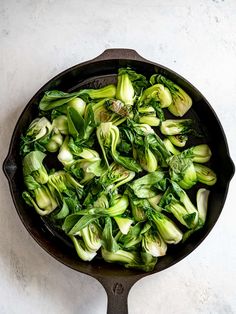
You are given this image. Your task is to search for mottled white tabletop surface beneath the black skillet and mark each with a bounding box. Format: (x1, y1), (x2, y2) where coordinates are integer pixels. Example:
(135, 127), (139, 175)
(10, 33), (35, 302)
(0, 0), (236, 314)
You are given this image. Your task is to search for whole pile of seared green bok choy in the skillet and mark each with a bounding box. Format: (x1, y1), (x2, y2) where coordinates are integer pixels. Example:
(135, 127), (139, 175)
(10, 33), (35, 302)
(20, 68), (216, 271)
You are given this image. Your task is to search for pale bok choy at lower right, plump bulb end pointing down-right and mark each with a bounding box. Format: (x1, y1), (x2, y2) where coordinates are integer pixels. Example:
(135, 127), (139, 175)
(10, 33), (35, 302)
(148, 211), (183, 244)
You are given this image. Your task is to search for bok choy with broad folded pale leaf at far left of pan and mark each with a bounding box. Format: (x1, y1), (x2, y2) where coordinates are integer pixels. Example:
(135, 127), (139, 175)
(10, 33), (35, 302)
(22, 151), (48, 184)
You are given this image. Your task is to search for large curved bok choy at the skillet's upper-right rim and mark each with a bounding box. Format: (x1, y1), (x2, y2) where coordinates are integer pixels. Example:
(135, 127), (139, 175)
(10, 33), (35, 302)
(150, 74), (192, 117)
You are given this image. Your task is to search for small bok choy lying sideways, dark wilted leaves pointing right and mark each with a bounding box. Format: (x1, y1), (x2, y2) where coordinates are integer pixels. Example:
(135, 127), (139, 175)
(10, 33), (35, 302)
(160, 119), (193, 135)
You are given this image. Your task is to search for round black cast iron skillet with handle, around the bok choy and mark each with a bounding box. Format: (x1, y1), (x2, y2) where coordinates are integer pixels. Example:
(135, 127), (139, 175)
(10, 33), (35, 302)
(3, 49), (234, 314)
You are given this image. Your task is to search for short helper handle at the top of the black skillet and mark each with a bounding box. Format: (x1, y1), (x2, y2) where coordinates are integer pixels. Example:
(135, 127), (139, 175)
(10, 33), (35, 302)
(92, 48), (147, 61)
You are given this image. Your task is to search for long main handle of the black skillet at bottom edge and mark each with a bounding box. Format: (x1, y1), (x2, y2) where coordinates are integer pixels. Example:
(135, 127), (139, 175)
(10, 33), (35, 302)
(97, 277), (138, 314)
